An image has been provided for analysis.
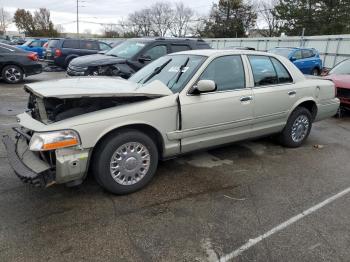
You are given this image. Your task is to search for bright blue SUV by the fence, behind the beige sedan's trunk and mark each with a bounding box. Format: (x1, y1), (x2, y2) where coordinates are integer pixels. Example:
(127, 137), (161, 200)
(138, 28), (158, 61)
(268, 47), (323, 75)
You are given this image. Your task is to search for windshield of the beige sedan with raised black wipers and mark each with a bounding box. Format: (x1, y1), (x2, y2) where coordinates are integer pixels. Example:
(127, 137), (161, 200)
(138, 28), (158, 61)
(129, 55), (206, 93)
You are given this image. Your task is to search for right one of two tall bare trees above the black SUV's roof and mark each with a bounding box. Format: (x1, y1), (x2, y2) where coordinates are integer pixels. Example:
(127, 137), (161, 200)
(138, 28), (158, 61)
(170, 2), (194, 37)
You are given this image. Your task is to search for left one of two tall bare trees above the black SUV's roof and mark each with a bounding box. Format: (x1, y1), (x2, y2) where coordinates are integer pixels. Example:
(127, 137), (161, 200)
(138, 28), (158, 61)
(150, 2), (174, 36)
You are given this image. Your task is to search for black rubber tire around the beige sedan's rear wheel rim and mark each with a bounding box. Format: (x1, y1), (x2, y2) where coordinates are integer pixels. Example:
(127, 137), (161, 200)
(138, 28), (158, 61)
(279, 107), (312, 148)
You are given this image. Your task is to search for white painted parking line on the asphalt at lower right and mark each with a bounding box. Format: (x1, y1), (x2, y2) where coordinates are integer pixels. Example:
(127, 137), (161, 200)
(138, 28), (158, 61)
(219, 187), (350, 262)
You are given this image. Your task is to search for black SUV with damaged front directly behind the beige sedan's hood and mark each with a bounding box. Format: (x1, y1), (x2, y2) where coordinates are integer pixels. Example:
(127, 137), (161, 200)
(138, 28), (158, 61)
(67, 38), (210, 78)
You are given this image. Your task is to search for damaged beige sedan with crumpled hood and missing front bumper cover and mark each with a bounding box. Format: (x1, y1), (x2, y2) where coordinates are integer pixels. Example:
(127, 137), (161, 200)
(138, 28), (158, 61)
(3, 50), (339, 194)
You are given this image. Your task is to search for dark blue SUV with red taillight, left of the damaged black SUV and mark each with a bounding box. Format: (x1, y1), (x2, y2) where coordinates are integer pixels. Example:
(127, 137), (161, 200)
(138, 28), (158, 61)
(44, 38), (112, 68)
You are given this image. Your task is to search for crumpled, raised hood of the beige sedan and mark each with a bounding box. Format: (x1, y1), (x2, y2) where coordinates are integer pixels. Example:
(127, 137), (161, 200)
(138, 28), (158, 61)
(24, 76), (172, 98)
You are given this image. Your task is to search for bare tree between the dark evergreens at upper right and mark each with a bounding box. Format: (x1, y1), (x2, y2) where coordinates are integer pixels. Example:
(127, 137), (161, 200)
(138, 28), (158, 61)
(258, 0), (281, 37)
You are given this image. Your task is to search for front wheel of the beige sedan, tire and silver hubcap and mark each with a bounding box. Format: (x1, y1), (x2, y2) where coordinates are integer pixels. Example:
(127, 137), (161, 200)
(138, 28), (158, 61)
(92, 129), (158, 195)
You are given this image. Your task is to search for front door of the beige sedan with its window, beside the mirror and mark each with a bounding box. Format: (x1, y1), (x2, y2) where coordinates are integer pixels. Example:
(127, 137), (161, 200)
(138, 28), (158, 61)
(179, 55), (253, 152)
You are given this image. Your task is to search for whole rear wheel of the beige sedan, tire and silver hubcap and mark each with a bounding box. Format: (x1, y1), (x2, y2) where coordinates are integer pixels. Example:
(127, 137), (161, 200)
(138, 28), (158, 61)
(279, 107), (312, 148)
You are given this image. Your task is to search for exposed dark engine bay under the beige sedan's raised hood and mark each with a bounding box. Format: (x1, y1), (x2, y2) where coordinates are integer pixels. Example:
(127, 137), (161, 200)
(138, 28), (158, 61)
(28, 93), (150, 123)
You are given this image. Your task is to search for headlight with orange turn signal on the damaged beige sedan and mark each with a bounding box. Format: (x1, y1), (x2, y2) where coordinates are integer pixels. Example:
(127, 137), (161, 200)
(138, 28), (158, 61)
(29, 130), (80, 151)
